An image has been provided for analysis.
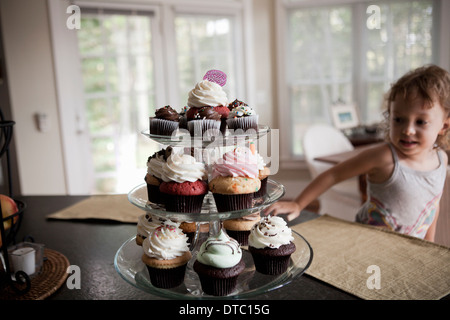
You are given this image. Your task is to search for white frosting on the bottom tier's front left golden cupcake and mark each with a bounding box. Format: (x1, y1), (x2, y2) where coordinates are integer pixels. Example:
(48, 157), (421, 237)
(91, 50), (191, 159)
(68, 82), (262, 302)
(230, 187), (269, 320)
(142, 225), (189, 260)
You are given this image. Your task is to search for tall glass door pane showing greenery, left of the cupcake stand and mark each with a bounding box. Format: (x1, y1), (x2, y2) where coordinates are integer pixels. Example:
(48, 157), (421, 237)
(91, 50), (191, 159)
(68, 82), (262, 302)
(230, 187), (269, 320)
(77, 9), (160, 193)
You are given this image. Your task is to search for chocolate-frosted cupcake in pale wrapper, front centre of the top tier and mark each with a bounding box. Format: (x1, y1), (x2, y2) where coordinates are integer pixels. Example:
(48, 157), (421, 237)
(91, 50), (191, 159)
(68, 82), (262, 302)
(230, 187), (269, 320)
(187, 107), (221, 137)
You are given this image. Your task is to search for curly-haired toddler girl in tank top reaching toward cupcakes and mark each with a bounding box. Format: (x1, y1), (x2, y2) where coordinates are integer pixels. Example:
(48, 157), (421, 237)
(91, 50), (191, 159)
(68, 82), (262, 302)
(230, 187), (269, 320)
(265, 65), (450, 241)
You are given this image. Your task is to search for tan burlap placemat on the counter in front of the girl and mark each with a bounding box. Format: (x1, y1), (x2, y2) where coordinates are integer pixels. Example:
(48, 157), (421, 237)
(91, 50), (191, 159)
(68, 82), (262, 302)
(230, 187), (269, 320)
(292, 215), (450, 300)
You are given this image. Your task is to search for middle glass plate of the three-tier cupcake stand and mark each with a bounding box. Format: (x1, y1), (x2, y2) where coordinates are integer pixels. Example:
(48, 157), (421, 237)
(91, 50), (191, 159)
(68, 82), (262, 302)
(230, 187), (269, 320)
(128, 179), (285, 221)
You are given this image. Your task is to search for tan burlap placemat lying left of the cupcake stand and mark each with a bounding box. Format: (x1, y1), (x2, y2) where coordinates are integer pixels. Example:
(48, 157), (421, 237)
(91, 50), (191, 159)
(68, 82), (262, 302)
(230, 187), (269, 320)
(47, 194), (144, 223)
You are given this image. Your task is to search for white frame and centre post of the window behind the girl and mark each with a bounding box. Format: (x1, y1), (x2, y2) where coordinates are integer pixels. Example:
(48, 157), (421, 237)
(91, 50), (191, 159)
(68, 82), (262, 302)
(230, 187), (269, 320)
(275, 0), (450, 169)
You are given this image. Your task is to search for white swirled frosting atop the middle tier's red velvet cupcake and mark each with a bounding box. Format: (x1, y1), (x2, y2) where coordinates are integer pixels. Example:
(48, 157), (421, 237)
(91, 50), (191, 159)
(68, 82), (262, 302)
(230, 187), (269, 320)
(161, 153), (207, 183)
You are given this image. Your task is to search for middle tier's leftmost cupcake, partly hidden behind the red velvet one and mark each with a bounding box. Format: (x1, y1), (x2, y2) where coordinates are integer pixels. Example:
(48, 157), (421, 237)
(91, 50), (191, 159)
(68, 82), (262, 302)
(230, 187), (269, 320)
(144, 147), (172, 204)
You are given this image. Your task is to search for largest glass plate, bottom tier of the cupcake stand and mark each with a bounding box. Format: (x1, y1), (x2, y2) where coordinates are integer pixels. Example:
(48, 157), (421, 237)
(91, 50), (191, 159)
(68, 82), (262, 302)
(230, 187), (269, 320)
(114, 231), (313, 299)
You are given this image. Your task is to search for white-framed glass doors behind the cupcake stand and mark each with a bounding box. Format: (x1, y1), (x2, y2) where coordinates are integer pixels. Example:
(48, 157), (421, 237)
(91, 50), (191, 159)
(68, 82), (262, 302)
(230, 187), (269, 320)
(49, 0), (253, 194)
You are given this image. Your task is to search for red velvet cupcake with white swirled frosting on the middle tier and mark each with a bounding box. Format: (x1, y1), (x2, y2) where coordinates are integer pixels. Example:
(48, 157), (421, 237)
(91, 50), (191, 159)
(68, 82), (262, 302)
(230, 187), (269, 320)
(159, 153), (208, 212)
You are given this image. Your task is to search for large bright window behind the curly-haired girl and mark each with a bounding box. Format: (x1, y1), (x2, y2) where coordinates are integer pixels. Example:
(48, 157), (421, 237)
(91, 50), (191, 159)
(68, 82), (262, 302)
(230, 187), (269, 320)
(279, 0), (438, 158)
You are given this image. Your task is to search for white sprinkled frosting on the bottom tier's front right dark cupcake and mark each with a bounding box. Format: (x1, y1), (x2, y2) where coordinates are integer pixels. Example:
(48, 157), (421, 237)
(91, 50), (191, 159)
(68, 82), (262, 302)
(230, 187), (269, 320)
(248, 216), (294, 249)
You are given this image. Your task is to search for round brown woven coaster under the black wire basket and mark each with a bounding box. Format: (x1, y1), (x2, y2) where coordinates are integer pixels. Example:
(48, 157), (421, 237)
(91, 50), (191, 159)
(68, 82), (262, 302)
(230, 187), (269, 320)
(0, 249), (69, 300)
